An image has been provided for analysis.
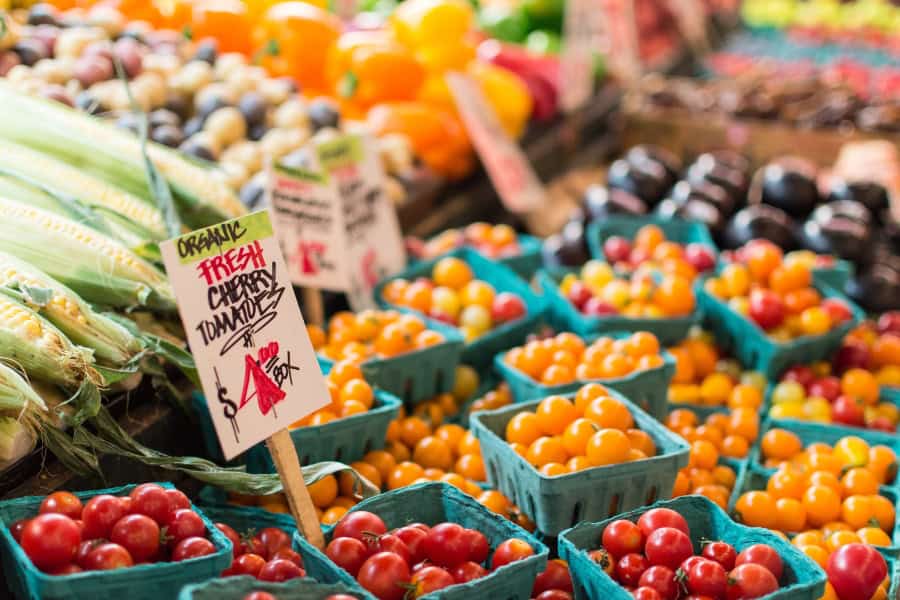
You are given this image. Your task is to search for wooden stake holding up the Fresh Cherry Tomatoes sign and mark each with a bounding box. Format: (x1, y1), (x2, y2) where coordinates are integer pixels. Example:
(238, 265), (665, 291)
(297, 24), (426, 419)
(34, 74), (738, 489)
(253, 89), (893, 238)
(266, 429), (325, 550)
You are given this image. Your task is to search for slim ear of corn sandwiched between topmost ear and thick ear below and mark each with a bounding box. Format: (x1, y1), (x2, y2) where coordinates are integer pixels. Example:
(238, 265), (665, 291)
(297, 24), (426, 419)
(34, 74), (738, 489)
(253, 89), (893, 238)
(0, 142), (166, 240)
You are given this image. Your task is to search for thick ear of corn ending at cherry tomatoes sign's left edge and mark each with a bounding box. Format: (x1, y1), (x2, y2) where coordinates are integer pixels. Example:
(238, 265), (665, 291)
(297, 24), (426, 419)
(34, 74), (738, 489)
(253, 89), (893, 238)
(0, 198), (175, 310)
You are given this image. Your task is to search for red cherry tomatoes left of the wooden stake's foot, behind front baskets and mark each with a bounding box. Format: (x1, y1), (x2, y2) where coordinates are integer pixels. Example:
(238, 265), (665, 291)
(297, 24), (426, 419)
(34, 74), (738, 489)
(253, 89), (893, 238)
(216, 523), (306, 581)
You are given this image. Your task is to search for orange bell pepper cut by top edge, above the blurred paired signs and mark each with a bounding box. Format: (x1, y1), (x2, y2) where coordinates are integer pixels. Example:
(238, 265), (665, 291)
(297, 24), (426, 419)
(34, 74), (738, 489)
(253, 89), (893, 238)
(257, 2), (342, 94)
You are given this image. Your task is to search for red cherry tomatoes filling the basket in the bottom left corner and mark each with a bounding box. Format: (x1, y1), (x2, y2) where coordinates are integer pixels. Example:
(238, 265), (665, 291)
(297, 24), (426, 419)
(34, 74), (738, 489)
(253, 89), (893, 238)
(10, 483), (216, 575)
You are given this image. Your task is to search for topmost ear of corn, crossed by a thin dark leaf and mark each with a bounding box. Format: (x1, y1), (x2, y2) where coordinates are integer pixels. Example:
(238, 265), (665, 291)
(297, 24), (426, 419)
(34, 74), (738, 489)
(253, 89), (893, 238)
(0, 83), (245, 227)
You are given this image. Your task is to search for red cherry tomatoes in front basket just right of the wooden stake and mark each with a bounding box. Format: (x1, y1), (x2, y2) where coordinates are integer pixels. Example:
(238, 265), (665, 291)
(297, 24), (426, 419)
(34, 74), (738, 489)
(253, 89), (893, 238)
(325, 511), (534, 600)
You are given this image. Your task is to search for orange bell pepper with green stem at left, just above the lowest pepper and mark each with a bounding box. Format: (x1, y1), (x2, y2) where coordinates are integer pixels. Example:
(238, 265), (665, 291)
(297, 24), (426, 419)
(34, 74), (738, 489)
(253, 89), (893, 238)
(327, 32), (425, 108)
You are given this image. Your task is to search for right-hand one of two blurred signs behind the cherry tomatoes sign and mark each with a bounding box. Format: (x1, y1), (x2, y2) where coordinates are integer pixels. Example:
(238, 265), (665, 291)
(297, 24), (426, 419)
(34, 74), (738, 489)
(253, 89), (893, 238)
(315, 135), (406, 311)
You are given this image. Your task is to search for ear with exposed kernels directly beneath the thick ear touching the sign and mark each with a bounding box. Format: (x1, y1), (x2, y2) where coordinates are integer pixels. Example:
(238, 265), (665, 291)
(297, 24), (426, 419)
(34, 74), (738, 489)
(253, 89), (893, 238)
(0, 252), (143, 366)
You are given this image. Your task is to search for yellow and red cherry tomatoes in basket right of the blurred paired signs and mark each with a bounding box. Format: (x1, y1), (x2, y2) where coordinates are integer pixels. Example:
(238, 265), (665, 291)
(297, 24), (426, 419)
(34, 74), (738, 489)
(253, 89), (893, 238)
(383, 256), (528, 341)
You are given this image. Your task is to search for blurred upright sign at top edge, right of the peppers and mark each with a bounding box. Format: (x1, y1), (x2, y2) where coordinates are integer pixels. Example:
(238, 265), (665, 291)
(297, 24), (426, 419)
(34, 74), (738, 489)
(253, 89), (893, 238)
(559, 0), (600, 113)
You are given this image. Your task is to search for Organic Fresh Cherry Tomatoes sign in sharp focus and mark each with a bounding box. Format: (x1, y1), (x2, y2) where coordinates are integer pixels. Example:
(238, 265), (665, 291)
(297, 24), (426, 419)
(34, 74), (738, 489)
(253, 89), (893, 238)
(160, 211), (331, 460)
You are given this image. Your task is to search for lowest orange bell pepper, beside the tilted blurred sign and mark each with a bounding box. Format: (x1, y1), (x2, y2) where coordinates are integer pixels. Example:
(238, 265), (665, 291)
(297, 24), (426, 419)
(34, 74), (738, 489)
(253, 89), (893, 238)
(367, 102), (474, 179)
